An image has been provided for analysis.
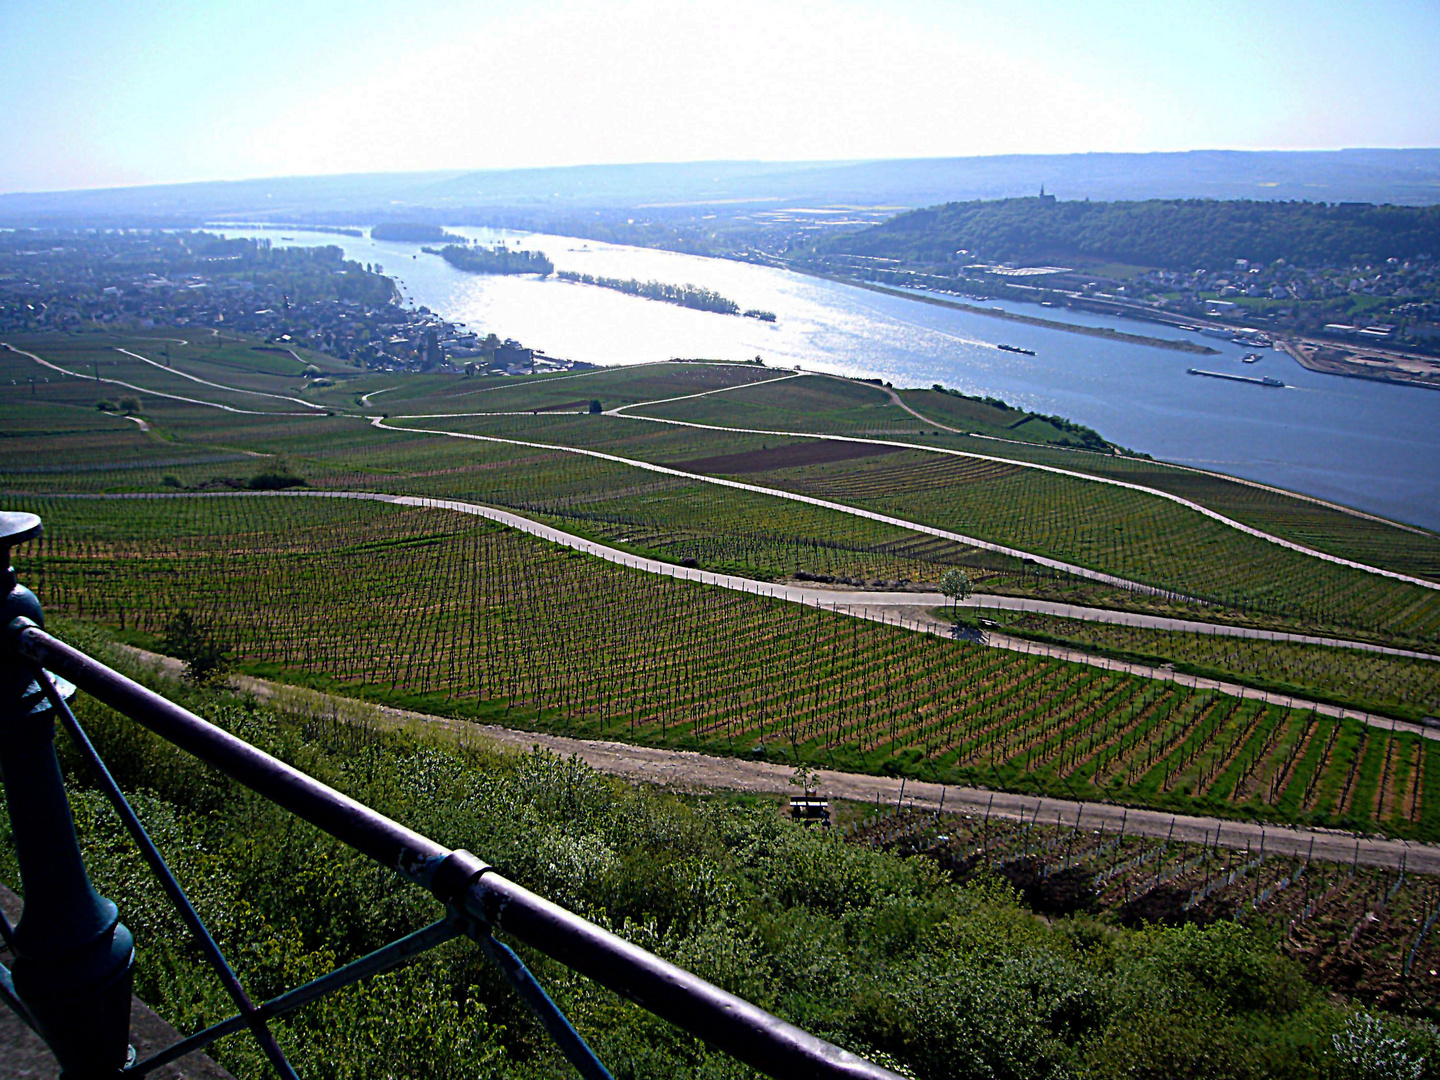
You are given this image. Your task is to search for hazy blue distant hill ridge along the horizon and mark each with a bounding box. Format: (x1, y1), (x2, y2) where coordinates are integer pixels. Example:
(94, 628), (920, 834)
(0, 148), (1440, 226)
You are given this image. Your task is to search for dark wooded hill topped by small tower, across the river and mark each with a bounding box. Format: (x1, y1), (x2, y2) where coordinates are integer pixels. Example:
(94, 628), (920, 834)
(818, 197), (1440, 271)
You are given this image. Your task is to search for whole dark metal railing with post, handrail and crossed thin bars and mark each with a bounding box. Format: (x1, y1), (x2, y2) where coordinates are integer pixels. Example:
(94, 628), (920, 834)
(0, 513), (897, 1080)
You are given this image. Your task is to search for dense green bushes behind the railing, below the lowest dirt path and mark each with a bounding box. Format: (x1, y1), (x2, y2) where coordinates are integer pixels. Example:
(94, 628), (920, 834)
(0, 642), (1434, 1080)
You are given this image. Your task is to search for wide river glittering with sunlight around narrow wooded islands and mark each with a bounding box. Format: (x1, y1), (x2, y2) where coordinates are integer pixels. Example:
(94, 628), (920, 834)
(216, 228), (1440, 528)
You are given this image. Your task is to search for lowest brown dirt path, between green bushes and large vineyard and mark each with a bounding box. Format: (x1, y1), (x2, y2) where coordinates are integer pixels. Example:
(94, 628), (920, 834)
(120, 649), (1440, 874)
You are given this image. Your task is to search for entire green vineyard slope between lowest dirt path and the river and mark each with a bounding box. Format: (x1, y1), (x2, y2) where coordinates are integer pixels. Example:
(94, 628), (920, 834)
(0, 336), (1440, 817)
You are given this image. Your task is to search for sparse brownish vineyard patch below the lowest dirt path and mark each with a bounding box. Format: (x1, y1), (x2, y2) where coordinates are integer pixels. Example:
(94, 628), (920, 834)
(844, 806), (1440, 1015)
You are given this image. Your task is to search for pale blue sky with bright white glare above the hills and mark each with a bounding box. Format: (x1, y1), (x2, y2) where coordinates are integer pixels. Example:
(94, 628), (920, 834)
(0, 0), (1440, 193)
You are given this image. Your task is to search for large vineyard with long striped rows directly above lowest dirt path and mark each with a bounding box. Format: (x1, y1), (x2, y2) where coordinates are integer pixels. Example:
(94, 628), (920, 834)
(7, 495), (1440, 838)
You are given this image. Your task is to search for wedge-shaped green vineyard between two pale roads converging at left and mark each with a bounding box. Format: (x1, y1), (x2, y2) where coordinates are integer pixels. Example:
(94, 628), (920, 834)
(402, 406), (1440, 641)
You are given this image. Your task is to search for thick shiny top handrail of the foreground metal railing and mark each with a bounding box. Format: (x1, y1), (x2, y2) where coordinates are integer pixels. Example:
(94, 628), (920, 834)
(11, 616), (899, 1080)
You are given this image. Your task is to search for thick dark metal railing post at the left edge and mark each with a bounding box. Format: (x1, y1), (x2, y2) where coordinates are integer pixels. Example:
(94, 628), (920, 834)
(0, 513), (135, 1080)
